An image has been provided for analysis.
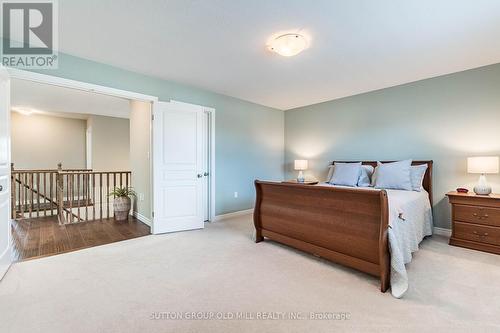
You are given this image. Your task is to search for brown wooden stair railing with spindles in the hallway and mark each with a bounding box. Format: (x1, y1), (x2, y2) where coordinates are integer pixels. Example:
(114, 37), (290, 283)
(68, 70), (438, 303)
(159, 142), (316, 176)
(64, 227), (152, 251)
(11, 163), (132, 224)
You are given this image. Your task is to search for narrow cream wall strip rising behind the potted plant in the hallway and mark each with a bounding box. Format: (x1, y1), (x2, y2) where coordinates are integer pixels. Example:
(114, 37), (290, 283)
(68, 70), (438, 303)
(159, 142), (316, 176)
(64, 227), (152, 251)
(130, 101), (151, 219)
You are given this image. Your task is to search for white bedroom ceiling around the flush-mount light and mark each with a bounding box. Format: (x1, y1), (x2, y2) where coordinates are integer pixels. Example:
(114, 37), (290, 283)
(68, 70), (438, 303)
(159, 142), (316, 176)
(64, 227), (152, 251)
(55, 0), (500, 109)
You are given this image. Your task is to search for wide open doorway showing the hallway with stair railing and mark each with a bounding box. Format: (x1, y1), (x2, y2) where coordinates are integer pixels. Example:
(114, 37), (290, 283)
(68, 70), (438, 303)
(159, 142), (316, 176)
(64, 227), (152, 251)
(10, 78), (152, 261)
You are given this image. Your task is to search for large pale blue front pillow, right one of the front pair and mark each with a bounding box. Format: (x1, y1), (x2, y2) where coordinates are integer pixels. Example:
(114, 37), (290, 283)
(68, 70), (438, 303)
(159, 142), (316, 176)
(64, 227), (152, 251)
(373, 160), (413, 191)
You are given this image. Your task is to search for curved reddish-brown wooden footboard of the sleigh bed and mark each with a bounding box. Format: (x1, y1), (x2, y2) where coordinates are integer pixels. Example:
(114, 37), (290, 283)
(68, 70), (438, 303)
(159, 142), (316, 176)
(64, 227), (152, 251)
(254, 181), (390, 292)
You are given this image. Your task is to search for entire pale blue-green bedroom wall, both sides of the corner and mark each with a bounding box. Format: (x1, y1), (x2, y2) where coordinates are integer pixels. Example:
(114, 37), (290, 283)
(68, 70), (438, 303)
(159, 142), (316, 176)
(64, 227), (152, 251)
(16, 48), (500, 227)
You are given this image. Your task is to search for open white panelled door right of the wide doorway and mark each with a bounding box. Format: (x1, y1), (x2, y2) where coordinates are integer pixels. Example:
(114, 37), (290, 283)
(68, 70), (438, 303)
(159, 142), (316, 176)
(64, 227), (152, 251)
(153, 102), (206, 234)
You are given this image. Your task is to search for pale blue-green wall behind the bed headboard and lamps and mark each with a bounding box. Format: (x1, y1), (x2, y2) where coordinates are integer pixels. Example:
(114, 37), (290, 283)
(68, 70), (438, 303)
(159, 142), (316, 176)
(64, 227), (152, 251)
(285, 64), (500, 228)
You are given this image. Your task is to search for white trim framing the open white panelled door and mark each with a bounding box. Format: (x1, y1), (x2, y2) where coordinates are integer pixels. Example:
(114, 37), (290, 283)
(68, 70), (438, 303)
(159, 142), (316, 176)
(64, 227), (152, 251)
(151, 99), (216, 234)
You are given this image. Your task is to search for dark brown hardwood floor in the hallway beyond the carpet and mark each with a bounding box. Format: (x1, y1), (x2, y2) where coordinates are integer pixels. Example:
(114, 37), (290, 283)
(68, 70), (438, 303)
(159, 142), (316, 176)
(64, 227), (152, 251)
(12, 216), (150, 261)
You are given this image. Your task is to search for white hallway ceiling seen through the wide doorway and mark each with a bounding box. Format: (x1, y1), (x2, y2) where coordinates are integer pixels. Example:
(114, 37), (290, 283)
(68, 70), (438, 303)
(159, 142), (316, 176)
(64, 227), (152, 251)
(11, 79), (130, 119)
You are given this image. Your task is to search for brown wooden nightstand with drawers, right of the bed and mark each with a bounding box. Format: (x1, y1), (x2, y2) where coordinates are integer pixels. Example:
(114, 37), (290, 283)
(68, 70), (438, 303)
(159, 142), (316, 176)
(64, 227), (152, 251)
(446, 192), (500, 254)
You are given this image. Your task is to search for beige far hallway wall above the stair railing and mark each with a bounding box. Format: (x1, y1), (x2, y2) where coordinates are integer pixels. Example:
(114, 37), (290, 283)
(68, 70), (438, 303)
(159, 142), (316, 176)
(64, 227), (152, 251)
(11, 112), (86, 169)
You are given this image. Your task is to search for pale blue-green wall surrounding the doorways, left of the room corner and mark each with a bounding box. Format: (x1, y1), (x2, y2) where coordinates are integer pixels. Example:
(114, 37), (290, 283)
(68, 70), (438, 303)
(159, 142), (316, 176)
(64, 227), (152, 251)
(28, 54), (284, 215)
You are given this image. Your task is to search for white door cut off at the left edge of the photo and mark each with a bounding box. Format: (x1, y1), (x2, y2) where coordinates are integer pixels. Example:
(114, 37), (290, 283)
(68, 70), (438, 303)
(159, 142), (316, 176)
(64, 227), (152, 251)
(0, 68), (11, 279)
